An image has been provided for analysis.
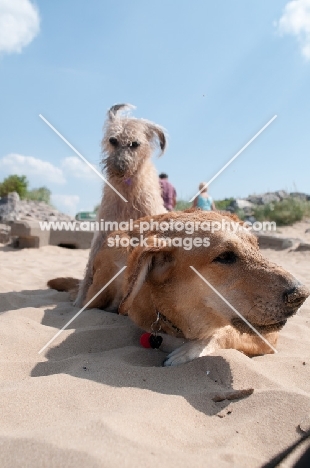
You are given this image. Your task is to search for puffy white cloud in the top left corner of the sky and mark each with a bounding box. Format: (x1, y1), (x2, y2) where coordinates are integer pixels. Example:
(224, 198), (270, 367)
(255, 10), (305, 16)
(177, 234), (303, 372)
(0, 0), (40, 53)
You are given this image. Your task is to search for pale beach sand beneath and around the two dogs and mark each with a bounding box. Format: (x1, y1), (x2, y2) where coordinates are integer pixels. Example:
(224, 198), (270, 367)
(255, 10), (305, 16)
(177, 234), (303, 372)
(0, 231), (310, 468)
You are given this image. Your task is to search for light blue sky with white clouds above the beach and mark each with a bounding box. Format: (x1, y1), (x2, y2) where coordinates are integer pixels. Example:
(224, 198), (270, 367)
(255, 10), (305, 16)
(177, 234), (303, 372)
(0, 0), (310, 214)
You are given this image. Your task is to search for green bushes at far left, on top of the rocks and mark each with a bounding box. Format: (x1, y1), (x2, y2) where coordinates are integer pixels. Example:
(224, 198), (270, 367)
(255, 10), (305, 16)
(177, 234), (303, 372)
(0, 174), (51, 205)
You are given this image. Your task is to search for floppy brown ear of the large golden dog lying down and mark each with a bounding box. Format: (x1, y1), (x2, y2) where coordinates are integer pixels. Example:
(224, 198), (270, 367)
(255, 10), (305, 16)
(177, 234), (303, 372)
(118, 243), (175, 315)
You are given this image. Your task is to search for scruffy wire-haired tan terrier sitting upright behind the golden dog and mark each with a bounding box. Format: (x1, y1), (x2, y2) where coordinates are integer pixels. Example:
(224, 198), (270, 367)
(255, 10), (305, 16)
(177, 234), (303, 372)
(75, 104), (167, 307)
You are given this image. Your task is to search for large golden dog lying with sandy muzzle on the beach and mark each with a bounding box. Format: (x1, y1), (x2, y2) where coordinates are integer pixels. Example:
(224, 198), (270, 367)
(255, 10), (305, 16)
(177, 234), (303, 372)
(48, 210), (309, 365)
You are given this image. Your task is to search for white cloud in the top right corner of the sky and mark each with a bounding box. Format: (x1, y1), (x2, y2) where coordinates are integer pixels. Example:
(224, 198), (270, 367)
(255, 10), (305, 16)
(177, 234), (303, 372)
(276, 0), (310, 60)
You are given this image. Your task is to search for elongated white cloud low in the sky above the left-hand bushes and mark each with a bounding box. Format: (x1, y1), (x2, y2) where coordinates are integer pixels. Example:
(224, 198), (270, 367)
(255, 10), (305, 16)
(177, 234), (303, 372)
(0, 153), (66, 185)
